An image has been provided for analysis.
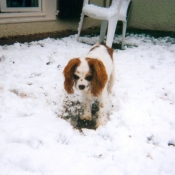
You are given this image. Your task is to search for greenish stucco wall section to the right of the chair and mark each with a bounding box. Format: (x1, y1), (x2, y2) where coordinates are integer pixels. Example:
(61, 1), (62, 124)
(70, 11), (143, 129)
(128, 0), (175, 31)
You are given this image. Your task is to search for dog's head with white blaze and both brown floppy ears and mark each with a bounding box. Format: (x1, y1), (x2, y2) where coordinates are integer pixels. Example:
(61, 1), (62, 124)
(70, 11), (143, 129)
(63, 57), (108, 96)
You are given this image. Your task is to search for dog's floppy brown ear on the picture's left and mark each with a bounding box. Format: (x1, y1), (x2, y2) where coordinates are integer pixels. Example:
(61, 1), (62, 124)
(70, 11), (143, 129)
(63, 58), (80, 94)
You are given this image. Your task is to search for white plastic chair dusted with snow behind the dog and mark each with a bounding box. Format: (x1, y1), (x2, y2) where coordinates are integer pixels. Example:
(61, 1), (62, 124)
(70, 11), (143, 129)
(77, 0), (131, 49)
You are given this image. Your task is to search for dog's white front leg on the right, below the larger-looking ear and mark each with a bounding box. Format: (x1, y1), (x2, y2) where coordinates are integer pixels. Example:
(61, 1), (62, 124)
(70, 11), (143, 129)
(96, 87), (109, 128)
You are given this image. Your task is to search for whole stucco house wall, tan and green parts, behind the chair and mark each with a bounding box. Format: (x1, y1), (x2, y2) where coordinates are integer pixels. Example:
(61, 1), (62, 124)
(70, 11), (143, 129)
(0, 0), (175, 38)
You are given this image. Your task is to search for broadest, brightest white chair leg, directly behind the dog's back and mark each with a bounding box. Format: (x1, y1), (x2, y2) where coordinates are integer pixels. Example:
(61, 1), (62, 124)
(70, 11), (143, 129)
(106, 17), (118, 47)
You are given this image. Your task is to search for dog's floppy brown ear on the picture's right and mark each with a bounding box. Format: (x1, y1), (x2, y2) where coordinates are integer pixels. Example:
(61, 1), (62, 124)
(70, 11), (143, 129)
(86, 58), (108, 96)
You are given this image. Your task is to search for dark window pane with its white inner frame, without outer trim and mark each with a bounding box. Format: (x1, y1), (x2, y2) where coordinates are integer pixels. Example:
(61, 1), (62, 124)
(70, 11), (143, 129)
(0, 0), (41, 12)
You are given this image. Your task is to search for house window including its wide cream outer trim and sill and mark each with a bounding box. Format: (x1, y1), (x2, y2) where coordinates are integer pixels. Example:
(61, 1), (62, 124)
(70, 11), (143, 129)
(0, 0), (57, 24)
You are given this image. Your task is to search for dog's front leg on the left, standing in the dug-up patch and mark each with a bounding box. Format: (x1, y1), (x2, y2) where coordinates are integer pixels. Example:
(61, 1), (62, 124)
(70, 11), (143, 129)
(80, 92), (92, 120)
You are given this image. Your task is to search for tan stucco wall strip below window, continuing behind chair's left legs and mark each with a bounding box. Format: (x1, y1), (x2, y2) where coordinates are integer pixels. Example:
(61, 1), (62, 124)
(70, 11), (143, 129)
(0, 18), (100, 38)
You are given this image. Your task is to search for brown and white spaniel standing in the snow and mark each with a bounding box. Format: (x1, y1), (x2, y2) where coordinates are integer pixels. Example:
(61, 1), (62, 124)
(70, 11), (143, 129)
(63, 44), (115, 127)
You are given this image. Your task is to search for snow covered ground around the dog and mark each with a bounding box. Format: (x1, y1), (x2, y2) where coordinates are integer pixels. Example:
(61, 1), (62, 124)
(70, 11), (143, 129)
(0, 35), (175, 175)
